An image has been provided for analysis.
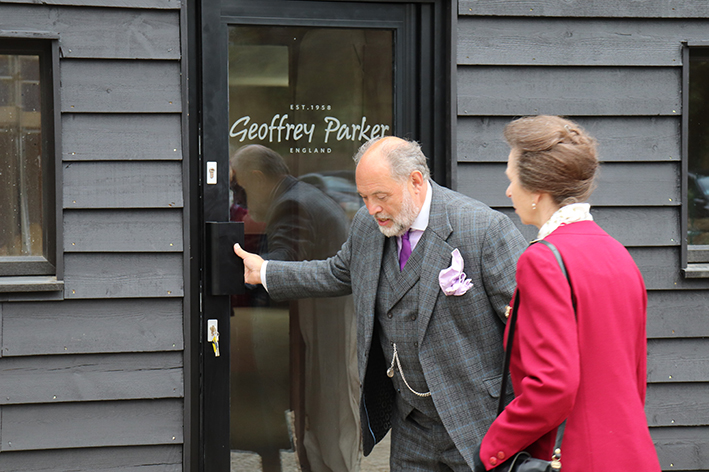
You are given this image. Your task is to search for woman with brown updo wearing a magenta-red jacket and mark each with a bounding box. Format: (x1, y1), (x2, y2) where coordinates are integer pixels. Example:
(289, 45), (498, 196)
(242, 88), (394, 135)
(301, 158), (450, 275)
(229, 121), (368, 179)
(475, 116), (660, 472)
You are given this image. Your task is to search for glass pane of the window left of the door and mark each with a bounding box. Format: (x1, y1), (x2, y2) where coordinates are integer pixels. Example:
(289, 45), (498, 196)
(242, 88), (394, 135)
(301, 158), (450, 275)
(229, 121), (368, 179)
(0, 54), (46, 262)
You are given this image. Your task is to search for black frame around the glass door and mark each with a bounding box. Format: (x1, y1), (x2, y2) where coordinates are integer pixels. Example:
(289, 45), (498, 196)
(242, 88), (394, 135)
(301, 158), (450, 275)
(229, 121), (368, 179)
(188, 0), (457, 472)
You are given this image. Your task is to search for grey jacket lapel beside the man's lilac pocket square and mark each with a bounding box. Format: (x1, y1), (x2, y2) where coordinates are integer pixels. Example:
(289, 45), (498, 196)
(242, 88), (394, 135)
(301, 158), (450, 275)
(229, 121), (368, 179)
(418, 181), (454, 344)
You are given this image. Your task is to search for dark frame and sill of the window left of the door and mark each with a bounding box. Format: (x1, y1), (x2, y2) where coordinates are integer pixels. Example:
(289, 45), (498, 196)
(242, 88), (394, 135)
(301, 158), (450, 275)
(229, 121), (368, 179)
(0, 30), (64, 294)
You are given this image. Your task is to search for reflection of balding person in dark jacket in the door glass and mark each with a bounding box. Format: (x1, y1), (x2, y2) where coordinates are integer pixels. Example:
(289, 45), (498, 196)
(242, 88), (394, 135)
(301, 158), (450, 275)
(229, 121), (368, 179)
(230, 145), (360, 472)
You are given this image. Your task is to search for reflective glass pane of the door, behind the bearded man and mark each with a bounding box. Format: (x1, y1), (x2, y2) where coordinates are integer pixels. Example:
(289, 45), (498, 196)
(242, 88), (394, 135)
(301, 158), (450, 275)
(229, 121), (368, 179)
(228, 25), (394, 472)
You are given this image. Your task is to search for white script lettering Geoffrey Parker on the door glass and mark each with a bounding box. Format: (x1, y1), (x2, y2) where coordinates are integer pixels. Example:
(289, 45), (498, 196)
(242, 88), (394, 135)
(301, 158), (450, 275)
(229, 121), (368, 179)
(229, 113), (390, 143)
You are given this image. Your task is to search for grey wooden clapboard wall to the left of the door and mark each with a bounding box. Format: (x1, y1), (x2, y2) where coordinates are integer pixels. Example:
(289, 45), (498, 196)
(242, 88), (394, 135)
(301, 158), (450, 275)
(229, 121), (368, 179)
(0, 0), (185, 471)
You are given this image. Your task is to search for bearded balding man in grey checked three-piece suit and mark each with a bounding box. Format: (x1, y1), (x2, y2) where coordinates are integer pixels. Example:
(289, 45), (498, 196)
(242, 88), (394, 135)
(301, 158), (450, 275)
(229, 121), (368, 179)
(235, 136), (526, 471)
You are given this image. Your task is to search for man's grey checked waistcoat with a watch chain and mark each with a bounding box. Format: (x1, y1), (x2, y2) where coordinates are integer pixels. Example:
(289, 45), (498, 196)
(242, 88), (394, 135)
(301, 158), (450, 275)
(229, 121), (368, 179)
(376, 233), (440, 421)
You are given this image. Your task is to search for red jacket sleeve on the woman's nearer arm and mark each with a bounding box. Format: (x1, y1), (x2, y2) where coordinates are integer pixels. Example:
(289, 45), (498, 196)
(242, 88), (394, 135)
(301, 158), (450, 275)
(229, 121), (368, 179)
(480, 245), (580, 467)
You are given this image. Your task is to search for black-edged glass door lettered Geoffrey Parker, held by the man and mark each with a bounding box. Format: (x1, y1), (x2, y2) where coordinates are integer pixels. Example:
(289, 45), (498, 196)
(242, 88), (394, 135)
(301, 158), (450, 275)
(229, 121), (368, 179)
(202, 0), (448, 472)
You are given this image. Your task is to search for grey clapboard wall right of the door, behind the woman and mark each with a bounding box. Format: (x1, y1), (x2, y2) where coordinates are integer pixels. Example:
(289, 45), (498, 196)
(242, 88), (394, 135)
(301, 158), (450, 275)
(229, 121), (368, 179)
(457, 0), (709, 471)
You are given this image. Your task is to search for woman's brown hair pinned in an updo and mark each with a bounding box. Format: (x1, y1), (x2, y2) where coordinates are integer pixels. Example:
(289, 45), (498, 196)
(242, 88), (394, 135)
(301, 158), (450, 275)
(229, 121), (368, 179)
(505, 115), (598, 206)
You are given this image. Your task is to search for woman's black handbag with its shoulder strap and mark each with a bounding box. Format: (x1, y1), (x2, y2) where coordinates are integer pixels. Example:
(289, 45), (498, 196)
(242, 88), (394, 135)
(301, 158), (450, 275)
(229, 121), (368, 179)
(494, 240), (576, 472)
